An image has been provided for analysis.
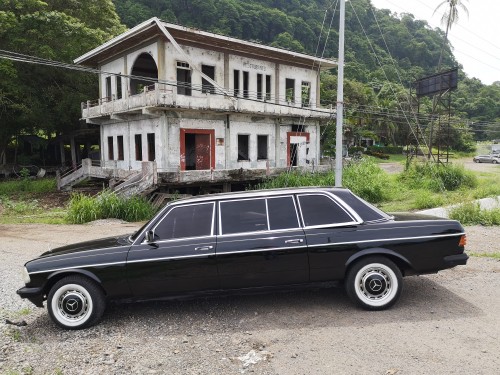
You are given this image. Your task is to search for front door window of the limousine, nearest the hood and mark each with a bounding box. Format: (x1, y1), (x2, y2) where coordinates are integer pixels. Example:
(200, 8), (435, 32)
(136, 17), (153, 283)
(154, 203), (214, 240)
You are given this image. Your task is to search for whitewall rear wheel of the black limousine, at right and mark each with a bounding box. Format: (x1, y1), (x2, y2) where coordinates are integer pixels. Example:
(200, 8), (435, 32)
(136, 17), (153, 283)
(345, 257), (403, 310)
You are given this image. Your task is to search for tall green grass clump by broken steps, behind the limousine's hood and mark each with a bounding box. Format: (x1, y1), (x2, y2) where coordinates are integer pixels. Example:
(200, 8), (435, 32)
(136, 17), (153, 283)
(67, 190), (156, 224)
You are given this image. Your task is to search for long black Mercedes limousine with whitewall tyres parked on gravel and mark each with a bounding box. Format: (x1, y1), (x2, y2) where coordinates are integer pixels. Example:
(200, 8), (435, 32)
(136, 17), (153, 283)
(17, 188), (468, 329)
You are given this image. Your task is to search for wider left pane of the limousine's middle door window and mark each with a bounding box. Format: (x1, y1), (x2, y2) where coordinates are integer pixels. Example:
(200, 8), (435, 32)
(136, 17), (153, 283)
(219, 199), (268, 234)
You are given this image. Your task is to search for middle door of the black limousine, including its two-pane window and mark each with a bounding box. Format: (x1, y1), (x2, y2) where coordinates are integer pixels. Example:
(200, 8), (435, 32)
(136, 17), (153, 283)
(217, 195), (309, 289)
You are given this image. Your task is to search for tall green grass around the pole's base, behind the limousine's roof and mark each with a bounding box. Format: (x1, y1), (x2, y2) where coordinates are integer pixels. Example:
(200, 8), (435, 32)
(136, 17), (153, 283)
(254, 159), (393, 203)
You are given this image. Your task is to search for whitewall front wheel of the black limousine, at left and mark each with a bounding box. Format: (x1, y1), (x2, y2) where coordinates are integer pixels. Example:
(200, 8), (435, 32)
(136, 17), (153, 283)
(47, 275), (106, 329)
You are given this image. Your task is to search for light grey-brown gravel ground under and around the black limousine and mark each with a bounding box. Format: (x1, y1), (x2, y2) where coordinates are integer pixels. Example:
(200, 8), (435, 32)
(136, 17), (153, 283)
(0, 221), (500, 374)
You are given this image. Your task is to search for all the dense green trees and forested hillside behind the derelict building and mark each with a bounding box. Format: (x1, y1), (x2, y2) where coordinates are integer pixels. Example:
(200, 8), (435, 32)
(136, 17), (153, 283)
(0, 0), (500, 165)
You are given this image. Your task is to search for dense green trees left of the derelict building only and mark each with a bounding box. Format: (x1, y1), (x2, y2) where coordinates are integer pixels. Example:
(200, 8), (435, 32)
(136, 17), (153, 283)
(0, 0), (125, 164)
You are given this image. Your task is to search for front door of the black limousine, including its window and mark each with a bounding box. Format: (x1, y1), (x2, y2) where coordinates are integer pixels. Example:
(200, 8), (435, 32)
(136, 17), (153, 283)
(127, 202), (219, 297)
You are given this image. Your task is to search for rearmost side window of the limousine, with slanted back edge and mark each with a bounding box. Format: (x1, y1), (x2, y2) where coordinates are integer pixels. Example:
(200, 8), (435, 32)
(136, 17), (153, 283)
(299, 194), (353, 227)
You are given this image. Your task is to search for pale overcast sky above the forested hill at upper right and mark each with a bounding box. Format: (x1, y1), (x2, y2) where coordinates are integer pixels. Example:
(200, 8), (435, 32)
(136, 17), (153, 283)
(370, 0), (500, 85)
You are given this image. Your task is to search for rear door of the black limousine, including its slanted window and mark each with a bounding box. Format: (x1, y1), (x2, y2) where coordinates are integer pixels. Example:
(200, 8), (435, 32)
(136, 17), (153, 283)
(297, 193), (362, 281)
